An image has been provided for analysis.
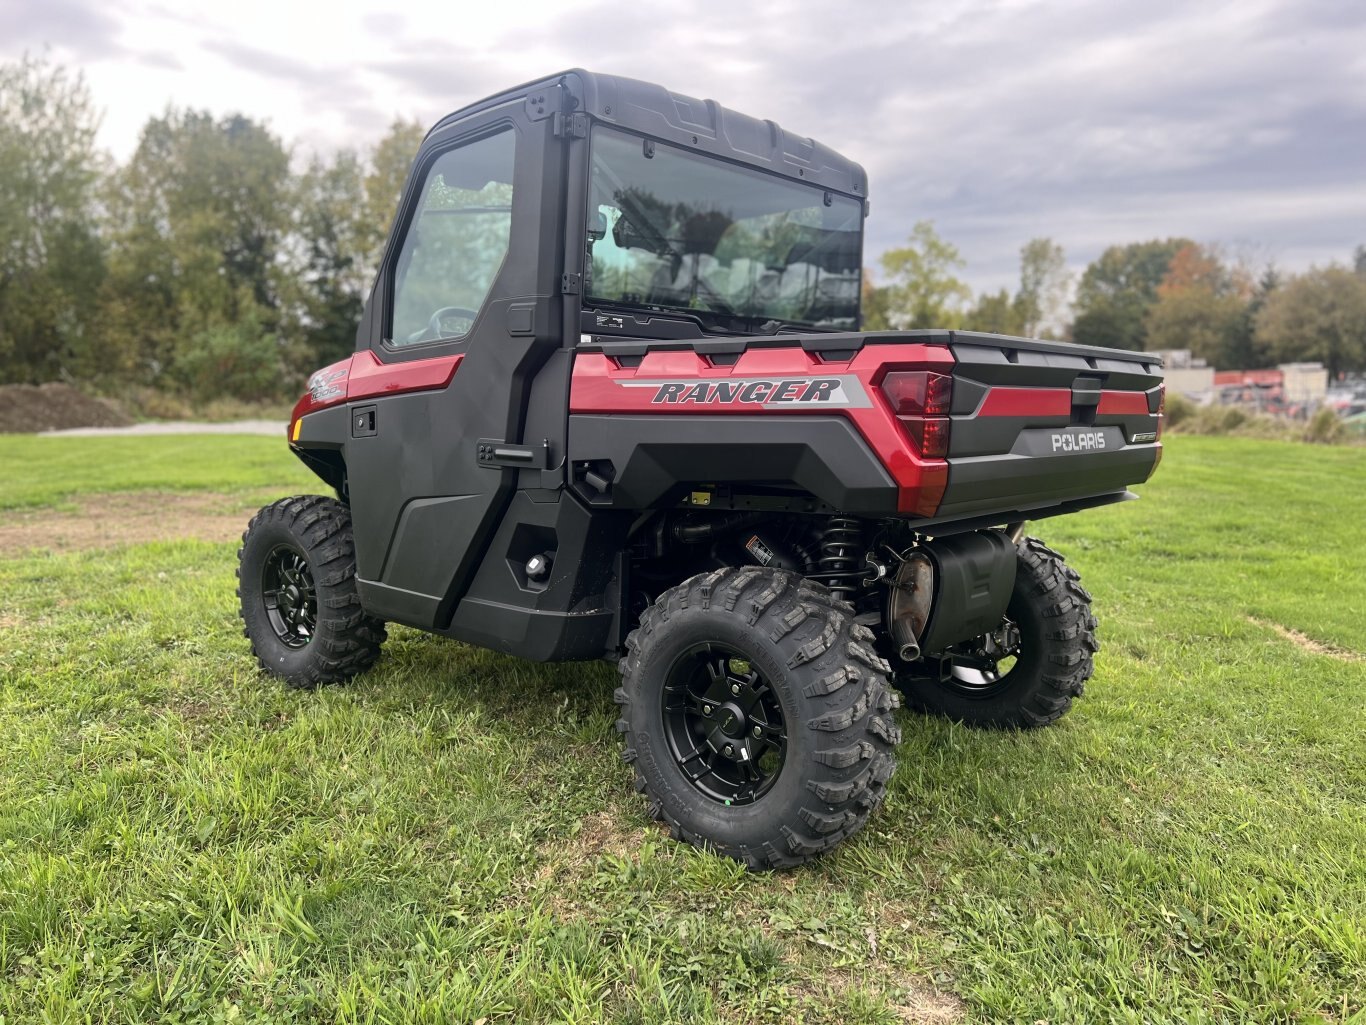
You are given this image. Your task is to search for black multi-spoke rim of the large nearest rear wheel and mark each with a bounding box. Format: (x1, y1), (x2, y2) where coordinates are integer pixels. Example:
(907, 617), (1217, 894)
(663, 642), (787, 805)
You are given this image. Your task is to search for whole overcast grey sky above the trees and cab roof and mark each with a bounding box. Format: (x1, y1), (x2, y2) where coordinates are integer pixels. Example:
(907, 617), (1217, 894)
(0, 0), (1366, 290)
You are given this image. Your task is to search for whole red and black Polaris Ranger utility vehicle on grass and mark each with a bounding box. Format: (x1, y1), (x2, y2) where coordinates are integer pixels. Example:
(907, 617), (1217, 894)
(238, 71), (1164, 868)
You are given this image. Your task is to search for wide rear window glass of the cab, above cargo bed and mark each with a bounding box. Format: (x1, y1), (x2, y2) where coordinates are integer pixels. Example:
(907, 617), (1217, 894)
(585, 128), (863, 329)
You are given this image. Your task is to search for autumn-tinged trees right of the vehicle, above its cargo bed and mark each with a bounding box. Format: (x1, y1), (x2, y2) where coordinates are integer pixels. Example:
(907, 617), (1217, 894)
(863, 221), (1366, 374)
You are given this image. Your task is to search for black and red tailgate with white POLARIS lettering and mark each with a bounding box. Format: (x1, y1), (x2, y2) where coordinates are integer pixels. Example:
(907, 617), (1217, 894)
(936, 331), (1162, 519)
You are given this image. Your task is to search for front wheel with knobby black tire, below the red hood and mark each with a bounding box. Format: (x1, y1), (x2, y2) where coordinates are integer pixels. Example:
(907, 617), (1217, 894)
(238, 495), (385, 687)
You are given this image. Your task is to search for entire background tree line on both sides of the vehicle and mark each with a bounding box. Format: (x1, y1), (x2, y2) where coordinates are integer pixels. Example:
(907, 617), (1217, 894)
(0, 57), (1366, 399)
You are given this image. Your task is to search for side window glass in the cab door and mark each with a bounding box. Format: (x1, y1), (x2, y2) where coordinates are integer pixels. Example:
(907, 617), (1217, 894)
(389, 130), (515, 346)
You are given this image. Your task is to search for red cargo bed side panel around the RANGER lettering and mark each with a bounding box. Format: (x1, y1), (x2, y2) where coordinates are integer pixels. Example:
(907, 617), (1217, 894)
(570, 344), (953, 515)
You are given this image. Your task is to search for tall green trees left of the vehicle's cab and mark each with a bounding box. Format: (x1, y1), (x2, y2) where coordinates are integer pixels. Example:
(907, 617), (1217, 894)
(0, 57), (423, 399)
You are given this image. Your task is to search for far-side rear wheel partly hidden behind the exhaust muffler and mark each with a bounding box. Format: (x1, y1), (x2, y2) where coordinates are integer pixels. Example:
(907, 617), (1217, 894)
(896, 537), (1100, 730)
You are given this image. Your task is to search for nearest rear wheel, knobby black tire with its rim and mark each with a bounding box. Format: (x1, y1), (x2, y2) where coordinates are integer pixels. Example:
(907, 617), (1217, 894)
(616, 567), (900, 869)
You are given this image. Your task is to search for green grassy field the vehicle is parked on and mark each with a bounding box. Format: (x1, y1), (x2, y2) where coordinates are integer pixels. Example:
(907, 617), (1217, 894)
(0, 437), (1366, 1025)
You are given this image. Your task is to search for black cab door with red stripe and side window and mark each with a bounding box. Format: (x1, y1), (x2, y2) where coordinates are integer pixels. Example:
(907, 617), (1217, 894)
(346, 97), (566, 629)
